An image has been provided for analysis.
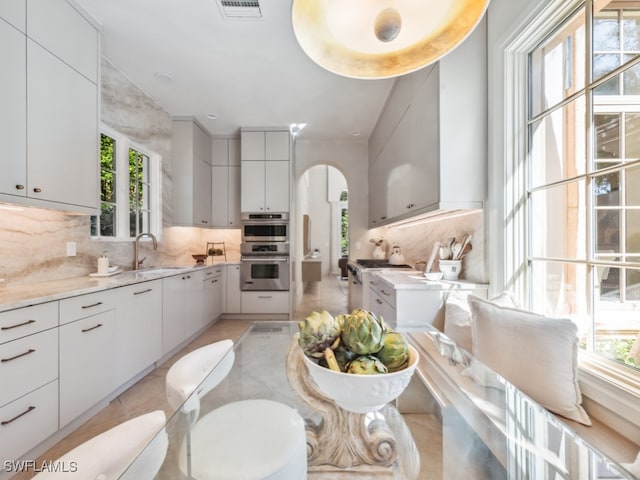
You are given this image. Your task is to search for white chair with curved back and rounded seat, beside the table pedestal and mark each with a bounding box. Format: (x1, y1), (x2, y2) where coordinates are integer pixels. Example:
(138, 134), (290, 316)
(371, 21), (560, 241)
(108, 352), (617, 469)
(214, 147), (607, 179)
(167, 340), (307, 480)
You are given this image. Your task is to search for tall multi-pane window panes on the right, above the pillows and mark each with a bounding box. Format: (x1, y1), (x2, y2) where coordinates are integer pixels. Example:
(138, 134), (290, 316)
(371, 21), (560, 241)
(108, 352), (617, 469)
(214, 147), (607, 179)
(527, 2), (640, 374)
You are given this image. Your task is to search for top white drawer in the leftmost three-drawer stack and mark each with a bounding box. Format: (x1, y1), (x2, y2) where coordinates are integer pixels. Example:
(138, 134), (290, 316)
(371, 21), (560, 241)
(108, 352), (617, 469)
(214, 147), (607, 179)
(0, 302), (58, 344)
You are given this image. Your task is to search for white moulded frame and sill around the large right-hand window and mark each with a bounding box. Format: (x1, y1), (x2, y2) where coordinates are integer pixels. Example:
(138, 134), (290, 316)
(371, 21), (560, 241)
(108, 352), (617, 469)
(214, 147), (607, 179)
(500, 0), (640, 438)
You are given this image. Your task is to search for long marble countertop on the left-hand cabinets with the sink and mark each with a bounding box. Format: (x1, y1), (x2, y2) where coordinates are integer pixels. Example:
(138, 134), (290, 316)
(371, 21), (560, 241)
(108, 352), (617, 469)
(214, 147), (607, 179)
(0, 261), (239, 312)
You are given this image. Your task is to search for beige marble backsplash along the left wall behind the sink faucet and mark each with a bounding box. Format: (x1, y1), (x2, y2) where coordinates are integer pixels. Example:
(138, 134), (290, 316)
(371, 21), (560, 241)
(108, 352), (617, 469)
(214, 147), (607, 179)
(0, 206), (240, 284)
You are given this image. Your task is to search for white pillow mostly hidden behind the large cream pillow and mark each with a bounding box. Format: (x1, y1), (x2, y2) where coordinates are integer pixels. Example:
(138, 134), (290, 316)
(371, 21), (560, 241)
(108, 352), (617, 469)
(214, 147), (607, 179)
(444, 291), (517, 352)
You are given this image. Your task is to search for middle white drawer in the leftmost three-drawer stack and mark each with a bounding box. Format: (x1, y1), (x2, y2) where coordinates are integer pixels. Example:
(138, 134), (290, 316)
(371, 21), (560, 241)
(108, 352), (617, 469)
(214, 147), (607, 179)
(0, 328), (58, 405)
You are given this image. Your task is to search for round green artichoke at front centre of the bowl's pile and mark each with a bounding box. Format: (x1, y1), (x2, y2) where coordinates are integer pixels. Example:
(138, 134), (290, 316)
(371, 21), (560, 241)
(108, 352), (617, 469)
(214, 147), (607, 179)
(341, 308), (387, 355)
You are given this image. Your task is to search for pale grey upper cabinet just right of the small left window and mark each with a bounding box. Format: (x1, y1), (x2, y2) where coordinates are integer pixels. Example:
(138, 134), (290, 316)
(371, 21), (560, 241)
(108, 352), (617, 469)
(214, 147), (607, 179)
(172, 118), (212, 227)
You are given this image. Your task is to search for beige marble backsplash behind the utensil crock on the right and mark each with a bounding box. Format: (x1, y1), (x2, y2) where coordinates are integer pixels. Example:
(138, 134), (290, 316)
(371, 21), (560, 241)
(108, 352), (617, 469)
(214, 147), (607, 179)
(369, 211), (489, 283)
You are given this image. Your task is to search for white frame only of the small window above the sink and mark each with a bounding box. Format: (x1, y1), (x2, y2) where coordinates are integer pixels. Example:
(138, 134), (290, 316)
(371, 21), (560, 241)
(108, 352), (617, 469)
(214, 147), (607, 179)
(91, 125), (162, 241)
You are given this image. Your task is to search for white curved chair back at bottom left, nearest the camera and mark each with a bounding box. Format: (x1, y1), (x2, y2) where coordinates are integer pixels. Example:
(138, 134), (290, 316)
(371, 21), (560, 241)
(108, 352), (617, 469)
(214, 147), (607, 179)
(33, 410), (168, 480)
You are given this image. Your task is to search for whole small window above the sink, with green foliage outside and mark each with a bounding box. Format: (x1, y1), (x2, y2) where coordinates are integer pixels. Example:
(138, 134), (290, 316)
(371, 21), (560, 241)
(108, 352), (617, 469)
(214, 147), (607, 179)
(91, 132), (160, 238)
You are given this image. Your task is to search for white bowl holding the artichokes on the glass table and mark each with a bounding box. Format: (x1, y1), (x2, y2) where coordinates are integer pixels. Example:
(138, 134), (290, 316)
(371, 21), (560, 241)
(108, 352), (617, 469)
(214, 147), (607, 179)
(303, 346), (419, 413)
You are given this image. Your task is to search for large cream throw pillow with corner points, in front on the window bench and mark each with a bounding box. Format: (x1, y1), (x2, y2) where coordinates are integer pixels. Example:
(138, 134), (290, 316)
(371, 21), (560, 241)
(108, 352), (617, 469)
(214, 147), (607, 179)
(467, 295), (591, 425)
